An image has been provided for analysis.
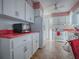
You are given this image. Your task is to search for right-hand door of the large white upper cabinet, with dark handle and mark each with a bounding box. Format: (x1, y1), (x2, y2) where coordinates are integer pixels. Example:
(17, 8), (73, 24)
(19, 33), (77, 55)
(15, 0), (25, 21)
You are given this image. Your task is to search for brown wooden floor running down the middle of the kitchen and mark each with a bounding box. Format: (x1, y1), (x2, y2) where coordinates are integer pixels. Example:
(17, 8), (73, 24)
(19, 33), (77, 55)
(31, 40), (74, 59)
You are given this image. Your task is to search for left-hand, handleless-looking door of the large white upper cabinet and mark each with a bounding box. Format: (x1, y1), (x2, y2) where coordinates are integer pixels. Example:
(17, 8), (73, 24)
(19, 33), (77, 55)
(3, 0), (15, 17)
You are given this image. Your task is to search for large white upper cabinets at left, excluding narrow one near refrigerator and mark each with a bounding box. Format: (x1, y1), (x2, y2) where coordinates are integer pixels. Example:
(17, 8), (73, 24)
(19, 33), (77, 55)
(0, 0), (25, 21)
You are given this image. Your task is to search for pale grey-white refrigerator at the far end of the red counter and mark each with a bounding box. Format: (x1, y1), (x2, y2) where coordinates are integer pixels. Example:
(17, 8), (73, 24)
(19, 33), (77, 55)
(31, 16), (43, 48)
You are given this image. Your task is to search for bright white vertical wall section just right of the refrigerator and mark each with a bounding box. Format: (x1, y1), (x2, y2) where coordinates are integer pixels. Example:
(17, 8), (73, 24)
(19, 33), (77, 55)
(43, 16), (53, 40)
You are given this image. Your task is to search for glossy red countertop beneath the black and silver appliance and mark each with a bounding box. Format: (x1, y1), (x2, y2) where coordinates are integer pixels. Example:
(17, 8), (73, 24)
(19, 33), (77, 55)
(0, 30), (33, 39)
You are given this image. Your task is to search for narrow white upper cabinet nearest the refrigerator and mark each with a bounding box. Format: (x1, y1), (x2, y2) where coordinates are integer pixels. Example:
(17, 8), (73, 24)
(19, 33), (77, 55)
(26, 2), (34, 23)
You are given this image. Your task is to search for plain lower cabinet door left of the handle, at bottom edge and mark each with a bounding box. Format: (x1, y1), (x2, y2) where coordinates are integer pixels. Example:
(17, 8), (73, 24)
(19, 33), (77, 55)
(13, 46), (24, 59)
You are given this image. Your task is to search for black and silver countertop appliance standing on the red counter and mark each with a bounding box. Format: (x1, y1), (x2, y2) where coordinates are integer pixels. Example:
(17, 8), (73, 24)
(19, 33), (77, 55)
(13, 23), (31, 33)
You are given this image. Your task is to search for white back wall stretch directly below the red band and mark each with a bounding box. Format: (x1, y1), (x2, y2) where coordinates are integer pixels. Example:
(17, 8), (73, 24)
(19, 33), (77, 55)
(53, 16), (70, 25)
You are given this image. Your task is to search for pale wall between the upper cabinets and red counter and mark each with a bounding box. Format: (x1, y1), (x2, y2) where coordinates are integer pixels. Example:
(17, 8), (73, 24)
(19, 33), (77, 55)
(0, 17), (25, 30)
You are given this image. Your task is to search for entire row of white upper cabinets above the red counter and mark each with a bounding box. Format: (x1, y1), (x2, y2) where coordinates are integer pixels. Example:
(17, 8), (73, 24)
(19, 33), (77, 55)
(0, 0), (34, 23)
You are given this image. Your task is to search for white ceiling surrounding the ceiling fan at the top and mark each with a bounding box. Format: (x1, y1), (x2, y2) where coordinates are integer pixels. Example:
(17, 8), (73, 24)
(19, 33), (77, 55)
(34, 0), (78, 15)
